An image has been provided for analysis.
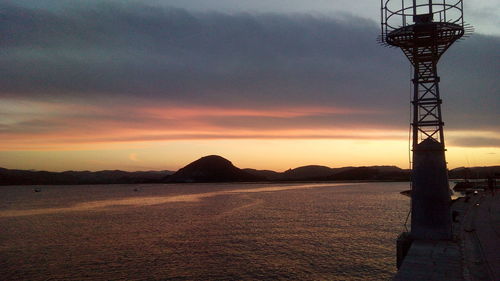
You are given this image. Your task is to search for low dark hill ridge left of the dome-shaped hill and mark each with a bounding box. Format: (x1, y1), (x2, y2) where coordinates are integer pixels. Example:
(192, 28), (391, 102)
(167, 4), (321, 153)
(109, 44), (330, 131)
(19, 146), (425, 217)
(0, 168), (173, 185)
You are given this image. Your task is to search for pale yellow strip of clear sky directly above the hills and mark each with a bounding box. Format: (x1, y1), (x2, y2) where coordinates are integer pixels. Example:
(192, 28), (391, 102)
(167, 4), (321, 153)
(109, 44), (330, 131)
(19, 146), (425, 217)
(0, 139), (500, 172)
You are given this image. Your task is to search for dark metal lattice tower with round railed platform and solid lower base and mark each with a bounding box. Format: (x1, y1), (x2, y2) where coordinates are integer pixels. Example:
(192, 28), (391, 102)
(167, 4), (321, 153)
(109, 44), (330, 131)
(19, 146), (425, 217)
(380, 0), (472, 239)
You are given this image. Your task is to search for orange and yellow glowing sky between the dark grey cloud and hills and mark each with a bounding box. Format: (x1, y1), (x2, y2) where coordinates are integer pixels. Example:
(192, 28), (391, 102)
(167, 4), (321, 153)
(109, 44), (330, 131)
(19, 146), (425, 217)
(0, 100), (500, 171)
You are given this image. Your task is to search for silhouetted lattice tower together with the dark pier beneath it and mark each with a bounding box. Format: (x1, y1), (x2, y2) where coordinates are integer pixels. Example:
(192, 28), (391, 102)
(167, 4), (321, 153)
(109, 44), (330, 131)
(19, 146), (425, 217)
(380, 0), (500, 281)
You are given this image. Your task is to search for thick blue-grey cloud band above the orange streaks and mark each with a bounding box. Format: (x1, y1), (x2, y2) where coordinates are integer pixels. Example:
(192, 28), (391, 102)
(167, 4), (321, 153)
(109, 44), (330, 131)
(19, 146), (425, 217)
(0, 2), (500, 132)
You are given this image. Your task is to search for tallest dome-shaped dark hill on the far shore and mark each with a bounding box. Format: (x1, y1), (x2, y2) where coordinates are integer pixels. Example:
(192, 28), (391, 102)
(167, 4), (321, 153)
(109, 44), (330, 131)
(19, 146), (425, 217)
(166, 155), (264, 182)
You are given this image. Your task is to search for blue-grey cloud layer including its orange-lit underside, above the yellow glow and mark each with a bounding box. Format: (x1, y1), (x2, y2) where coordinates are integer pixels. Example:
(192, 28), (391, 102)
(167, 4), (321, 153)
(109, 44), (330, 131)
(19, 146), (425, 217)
(0, 2), (500, 149)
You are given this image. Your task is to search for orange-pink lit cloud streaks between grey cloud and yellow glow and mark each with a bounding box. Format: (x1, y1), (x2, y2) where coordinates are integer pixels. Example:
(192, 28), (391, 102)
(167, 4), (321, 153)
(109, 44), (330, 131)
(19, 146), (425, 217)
(5, 100), (498, 152)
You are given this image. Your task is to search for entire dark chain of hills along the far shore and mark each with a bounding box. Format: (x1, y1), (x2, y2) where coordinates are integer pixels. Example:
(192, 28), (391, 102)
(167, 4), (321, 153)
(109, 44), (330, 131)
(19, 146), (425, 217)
(0, 155), (500, 185)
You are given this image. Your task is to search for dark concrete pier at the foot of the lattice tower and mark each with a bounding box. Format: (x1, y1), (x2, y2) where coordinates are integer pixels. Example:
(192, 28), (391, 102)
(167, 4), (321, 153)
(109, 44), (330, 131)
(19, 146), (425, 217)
(393, 190), (500, 281)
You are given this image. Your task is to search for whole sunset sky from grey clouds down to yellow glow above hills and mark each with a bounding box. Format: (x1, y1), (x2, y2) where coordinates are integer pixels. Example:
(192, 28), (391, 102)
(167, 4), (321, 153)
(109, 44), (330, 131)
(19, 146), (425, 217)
(0, 0), (500, 171)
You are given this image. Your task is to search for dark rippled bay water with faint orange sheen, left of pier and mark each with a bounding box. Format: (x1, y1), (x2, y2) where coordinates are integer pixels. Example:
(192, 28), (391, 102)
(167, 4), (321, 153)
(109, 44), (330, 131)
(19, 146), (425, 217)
(0, 180), (409, 280)
